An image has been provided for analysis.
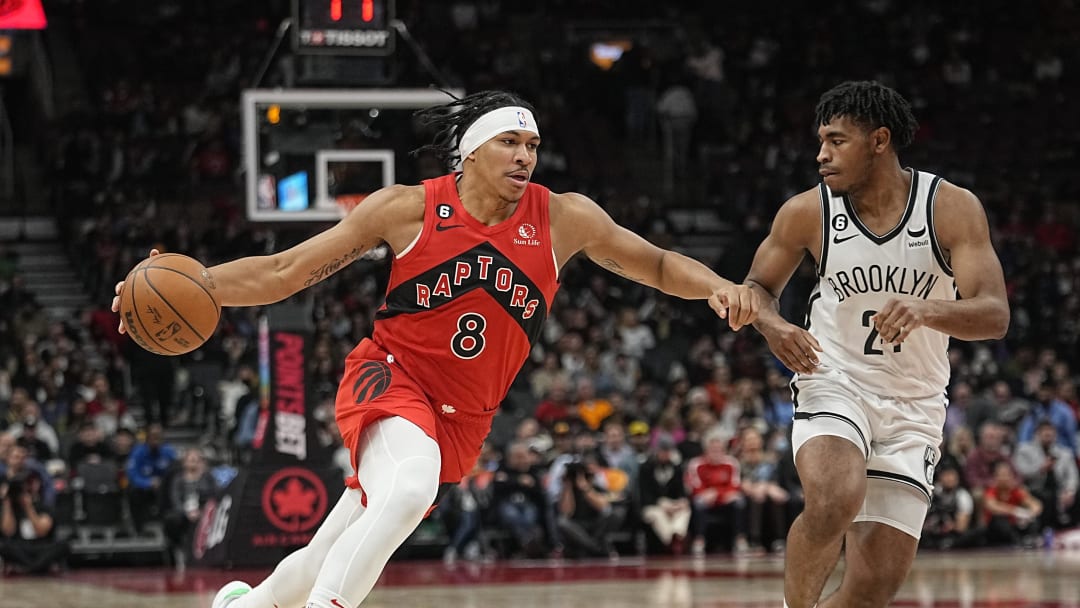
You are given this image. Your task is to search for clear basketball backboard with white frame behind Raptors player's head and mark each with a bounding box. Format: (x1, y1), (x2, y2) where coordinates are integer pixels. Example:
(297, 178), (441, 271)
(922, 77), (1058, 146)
(242, 89), (463, 221)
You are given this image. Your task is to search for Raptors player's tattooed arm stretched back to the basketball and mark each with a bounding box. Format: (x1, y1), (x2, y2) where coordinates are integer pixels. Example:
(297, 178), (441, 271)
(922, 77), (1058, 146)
(208, 186), (423, 306)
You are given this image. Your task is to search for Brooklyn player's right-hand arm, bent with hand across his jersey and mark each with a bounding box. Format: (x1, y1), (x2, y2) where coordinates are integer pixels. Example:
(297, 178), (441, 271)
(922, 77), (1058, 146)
(873, 183), (1009, 343)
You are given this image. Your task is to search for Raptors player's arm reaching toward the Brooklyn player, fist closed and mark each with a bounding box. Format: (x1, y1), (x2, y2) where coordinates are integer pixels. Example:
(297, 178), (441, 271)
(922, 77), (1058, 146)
(551, 193), (758, 329)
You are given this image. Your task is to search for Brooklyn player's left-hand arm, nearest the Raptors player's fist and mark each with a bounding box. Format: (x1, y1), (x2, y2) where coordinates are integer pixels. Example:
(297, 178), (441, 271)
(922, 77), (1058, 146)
(746, 190), (821, 374)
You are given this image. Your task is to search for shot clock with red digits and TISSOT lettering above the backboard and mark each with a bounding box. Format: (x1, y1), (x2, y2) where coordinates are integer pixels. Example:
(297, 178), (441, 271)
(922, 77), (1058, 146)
(293, 0), (394, 56)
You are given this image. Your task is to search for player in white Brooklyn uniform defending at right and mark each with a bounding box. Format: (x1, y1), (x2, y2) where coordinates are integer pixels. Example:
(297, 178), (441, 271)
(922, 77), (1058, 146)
(746, 82), (1009, 608)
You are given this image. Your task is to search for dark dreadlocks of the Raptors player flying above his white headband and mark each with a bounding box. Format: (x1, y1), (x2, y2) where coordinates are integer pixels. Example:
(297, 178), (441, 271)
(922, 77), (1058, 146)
(413, 91), (536, 170)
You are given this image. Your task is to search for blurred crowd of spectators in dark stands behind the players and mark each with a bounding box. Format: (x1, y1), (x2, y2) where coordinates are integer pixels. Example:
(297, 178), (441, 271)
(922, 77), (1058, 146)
(0, 0), (1080, 570)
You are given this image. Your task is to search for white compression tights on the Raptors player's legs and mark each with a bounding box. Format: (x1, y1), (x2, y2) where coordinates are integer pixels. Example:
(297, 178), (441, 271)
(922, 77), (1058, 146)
(235, 418), (442, 608)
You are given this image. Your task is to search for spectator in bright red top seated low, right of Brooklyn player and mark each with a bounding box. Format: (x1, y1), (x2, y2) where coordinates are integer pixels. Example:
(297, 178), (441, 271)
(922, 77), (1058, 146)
(983, 460), (1042, 546)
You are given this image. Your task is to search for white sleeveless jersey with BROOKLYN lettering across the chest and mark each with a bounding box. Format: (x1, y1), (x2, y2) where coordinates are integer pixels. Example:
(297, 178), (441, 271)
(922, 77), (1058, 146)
(807, 170), (956, 398)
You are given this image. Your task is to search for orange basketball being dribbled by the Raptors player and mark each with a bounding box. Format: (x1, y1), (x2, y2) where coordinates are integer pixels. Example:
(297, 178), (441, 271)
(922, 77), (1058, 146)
(120, 254), (221, 355)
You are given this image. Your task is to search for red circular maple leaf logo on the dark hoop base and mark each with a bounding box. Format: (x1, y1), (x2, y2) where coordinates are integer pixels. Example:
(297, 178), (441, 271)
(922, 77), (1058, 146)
(262, 467), (327, 532)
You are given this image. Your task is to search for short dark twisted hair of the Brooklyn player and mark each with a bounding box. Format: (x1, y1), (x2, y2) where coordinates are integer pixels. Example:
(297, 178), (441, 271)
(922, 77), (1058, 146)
(815, 80), (919, 150)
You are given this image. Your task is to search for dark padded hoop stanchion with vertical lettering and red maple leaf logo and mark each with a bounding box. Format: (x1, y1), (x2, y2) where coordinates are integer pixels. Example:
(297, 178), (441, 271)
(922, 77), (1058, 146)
(194, 311), (345, 567)
